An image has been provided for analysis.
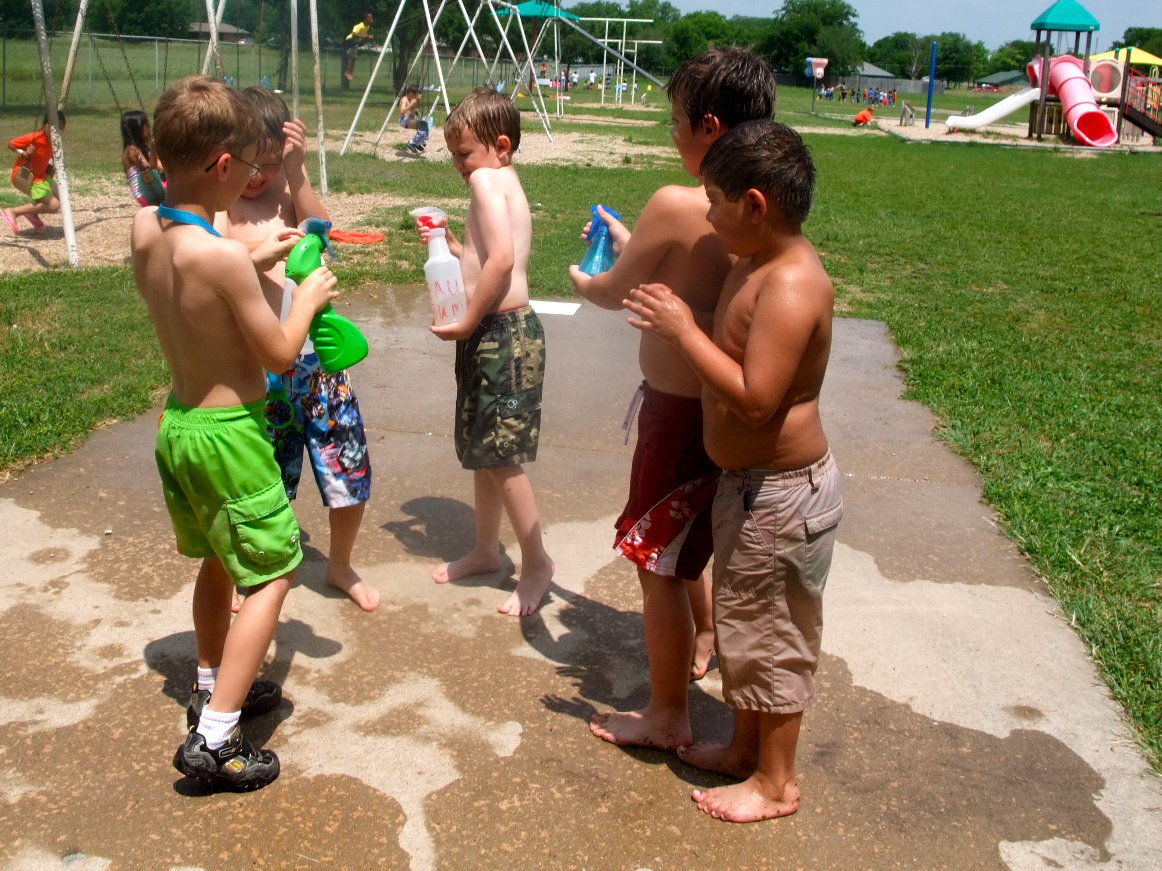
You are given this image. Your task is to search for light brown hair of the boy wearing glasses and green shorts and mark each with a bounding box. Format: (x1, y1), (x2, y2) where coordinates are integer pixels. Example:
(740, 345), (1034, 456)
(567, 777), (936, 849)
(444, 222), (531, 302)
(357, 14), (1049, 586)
(153, 75), (263, 173)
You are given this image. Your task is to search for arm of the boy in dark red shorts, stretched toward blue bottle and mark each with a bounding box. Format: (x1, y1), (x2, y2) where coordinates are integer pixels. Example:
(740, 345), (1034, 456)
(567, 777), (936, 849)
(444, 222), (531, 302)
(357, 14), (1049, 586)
(569, 186), (688, 310)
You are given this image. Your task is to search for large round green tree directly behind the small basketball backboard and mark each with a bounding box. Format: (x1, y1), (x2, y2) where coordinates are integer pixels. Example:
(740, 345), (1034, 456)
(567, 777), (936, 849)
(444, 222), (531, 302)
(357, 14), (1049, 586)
(758, 0), (865, 75)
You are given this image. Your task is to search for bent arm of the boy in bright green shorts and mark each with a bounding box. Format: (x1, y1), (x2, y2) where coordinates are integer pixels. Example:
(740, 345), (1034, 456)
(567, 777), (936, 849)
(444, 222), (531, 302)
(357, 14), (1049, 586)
(208, 244), (338, 372)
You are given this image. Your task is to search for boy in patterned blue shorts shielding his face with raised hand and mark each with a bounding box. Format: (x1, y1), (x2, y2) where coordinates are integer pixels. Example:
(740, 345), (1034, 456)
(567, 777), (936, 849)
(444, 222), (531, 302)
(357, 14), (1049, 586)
(218, 87), (380, 611)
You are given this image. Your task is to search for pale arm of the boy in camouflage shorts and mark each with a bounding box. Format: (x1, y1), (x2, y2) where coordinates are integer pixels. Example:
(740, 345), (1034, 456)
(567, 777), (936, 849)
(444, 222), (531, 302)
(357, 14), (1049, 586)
(430, 170), (516, 339)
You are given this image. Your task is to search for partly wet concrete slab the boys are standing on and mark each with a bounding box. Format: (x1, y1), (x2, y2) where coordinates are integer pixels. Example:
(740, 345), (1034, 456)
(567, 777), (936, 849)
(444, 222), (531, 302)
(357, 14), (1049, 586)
(0, 289), (1162, 871)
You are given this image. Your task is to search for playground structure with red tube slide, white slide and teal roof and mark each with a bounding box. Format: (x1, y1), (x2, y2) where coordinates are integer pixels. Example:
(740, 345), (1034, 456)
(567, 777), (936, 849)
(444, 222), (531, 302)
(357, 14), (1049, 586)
(946, 0), (1162, 147)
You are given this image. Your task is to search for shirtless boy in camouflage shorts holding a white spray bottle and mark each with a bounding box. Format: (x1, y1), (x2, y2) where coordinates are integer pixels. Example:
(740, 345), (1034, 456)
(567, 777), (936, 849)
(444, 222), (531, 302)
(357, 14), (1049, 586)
(419, 88), (553, 617)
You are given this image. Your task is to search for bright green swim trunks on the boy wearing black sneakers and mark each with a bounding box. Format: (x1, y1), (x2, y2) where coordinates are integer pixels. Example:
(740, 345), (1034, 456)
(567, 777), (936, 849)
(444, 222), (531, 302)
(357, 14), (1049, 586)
(155, 396), (302, 586)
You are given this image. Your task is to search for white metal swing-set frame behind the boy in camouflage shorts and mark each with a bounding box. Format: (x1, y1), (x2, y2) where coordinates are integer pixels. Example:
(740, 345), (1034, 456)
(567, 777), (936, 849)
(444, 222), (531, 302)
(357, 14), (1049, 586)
(339, 0), (662, 154)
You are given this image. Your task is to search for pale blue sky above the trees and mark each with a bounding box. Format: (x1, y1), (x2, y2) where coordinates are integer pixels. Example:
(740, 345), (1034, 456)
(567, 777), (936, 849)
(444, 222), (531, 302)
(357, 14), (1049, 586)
(669, 0), (1162, 51)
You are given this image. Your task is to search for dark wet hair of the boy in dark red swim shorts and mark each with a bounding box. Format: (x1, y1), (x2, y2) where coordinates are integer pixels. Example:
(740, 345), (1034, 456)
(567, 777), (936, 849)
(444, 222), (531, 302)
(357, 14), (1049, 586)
(666, 45), (775, 127)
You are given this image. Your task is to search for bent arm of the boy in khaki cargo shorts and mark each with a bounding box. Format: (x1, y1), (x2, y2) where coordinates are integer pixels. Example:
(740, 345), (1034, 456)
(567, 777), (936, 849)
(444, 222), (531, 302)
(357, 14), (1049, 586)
(625, 274), (815, 427)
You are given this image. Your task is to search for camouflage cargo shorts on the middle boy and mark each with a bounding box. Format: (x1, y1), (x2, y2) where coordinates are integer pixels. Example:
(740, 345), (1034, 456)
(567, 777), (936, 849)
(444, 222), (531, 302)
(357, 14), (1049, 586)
(454, 305), (545, 469)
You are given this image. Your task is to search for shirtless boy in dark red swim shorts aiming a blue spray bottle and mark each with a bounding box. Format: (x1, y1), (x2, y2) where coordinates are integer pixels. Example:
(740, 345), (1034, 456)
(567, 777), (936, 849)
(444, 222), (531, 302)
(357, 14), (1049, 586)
(569, 48), (775, 749)
